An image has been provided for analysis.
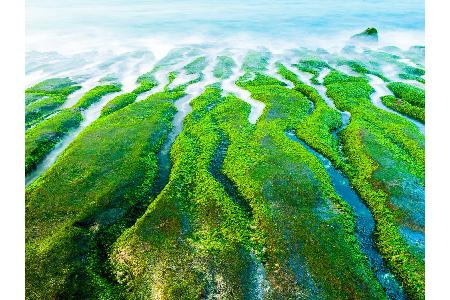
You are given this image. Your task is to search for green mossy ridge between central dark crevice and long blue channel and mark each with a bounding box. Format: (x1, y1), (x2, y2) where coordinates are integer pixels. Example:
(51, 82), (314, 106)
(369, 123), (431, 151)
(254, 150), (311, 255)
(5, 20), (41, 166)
(221, 75), (383, 298)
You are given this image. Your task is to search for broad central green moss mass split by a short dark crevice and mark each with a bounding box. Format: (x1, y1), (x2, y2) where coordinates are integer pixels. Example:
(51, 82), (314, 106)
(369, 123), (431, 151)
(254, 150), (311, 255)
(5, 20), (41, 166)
(112, 74), (383, 299)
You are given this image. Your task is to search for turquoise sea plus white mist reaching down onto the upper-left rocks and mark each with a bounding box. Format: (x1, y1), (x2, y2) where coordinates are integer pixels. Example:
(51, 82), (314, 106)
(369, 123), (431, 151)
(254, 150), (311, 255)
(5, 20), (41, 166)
(25, 0), (424, 89)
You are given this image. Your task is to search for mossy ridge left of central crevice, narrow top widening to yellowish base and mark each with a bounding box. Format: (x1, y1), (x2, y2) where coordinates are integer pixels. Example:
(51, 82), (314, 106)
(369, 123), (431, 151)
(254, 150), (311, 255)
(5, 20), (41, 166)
(112, 87), (249, 299)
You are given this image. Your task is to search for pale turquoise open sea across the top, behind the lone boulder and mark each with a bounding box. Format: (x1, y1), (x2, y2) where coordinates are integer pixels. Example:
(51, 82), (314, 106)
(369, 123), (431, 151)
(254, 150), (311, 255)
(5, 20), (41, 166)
(26, 0), (424, 50)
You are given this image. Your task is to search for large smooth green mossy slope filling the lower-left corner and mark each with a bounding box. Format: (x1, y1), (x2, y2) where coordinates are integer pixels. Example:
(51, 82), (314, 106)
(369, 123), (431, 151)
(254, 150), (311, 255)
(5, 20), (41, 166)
(26, 93), (179, 299)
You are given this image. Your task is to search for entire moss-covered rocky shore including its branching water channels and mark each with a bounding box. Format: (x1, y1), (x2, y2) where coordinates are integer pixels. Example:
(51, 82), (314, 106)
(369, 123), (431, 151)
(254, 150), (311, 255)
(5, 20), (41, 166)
(25, 44), (425, 299)
